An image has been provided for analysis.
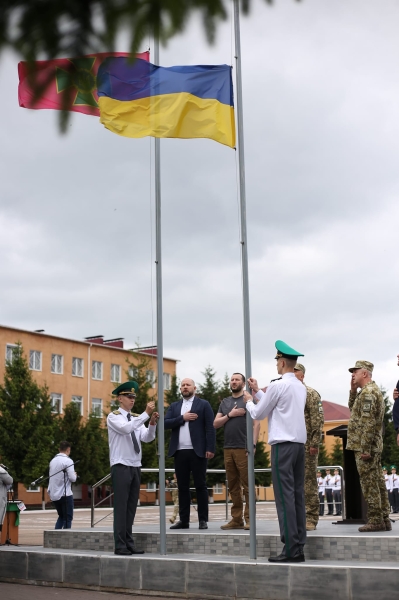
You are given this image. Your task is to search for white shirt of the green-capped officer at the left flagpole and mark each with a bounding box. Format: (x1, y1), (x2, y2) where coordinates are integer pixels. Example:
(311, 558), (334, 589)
(107, 408), (152, 467)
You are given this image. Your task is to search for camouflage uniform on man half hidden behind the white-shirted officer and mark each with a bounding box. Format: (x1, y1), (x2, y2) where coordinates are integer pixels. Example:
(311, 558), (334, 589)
(305, 386), (324, 526)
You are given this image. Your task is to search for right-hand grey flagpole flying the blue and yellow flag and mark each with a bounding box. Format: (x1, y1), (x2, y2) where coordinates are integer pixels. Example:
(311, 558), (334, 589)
(234, 0), (256, 558)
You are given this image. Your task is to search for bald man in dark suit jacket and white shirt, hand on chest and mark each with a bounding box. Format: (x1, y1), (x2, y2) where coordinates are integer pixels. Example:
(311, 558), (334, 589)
(165, 379), (216, 529)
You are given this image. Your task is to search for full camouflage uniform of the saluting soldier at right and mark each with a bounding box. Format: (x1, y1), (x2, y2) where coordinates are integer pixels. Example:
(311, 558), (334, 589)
(346, 381), (389, 525)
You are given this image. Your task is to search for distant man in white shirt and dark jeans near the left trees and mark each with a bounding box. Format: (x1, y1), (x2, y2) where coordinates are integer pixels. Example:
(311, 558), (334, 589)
(47, 442), (78, 529)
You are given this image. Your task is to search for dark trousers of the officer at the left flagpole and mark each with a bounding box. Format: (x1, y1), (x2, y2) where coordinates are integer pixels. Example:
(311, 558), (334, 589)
(111, 464), (141, 550)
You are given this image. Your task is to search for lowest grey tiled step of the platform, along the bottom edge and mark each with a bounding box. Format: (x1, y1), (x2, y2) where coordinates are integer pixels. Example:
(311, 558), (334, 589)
(0, 546), (399, 600)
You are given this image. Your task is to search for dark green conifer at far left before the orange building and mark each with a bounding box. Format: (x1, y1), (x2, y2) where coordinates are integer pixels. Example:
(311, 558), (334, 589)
(0, 344), (55, 495)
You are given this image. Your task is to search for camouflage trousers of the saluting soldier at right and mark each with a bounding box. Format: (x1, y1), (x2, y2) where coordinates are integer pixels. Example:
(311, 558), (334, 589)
(355, 452), (389, 524)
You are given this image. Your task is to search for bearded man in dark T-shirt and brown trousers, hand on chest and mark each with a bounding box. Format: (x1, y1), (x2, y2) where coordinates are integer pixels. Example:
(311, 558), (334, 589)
(213, 373), (260, 529)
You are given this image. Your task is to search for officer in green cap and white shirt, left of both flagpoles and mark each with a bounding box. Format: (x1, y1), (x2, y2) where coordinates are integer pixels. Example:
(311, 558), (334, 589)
(107, 381), (159, 556)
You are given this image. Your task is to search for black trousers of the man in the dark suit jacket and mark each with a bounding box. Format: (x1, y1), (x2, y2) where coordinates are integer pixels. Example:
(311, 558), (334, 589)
(175, 450), (208, 523)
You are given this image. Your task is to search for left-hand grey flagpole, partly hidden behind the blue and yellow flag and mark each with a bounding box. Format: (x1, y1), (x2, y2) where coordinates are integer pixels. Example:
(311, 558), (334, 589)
(154, 35), (166, 554)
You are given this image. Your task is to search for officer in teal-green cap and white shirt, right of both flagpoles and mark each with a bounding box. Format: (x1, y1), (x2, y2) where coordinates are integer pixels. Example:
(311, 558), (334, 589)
(244, 340), (307, 563)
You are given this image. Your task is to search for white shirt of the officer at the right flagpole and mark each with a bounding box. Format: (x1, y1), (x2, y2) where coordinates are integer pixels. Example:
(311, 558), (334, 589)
(247, 373), (307, 446)
